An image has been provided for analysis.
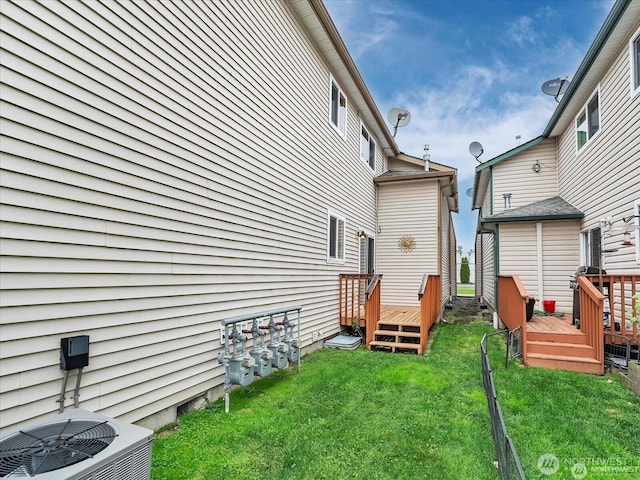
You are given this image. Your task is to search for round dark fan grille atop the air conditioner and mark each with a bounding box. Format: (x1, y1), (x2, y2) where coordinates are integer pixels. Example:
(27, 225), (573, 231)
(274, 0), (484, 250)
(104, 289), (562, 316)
(0, 420), (116, 477)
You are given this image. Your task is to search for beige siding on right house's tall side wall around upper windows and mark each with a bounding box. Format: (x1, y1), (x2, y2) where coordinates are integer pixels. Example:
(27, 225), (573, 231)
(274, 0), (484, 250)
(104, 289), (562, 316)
(559, 20), (640, 273)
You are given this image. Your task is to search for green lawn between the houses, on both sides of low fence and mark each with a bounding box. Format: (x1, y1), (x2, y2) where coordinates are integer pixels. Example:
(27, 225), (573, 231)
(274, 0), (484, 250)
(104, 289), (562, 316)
(152, 319), (640, 480)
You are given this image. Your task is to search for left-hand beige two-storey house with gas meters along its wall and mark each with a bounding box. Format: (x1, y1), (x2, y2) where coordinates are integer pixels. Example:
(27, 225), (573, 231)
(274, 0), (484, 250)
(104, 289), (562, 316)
(0, 0), (457, 433)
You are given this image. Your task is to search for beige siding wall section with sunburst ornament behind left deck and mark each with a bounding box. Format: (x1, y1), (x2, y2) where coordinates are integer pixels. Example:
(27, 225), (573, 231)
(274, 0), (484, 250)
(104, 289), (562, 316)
(376, 181), (441, 305)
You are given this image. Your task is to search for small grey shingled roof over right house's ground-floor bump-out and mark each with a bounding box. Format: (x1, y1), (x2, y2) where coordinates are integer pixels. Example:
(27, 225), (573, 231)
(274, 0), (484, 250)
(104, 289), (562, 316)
(481, 196), (584, 225)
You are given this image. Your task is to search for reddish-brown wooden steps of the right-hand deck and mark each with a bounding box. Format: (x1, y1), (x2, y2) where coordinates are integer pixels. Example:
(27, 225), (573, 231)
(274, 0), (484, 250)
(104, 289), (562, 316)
(526, 329), (602, 374)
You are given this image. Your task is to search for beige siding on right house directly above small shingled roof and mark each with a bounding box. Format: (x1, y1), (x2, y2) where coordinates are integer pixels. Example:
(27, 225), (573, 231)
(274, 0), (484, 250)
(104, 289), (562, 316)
(492, 139), (558, 215)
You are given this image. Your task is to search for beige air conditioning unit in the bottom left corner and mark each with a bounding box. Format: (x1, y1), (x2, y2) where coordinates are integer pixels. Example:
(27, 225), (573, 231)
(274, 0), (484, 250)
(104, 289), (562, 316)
(0, 409), (153, 480)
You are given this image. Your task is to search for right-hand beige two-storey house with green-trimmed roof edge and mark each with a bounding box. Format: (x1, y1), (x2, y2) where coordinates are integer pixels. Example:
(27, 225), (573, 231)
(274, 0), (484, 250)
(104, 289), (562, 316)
(472, 0), (640, 312)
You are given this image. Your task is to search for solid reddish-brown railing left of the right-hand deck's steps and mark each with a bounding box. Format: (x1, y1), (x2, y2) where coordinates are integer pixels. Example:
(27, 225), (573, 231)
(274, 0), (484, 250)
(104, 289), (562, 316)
(498, 275), (529, 363)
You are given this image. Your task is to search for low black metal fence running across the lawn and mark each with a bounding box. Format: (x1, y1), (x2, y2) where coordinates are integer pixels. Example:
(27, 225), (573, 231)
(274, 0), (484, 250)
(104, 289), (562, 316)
(480, 331), (526, 480)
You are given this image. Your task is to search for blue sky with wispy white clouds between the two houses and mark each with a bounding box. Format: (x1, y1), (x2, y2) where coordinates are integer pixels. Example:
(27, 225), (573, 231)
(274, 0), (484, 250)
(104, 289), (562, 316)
(324, 0), (613, 255)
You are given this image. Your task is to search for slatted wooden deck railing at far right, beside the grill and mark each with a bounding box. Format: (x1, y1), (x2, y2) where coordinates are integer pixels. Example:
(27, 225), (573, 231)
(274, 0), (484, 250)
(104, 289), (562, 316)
(580, 274), (640, 338)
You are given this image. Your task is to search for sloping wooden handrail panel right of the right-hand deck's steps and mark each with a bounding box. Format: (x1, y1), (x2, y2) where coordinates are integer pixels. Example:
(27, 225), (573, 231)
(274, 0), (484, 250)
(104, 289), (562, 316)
(577, 275), (605, 371)
